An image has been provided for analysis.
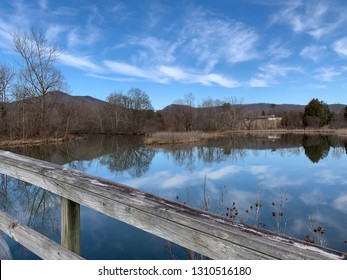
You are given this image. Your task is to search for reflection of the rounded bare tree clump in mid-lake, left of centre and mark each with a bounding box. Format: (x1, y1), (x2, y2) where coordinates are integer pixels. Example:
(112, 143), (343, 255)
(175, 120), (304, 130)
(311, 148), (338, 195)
(100, 142), (155, 177)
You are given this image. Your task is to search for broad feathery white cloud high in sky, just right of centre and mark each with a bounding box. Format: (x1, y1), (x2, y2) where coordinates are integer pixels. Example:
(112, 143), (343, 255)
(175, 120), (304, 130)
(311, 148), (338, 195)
(179, 9), (259, 69)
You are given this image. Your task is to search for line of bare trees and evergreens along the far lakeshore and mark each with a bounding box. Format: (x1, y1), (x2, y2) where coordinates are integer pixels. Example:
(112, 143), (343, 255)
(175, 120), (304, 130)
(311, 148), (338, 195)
(0, 29), (347, 139)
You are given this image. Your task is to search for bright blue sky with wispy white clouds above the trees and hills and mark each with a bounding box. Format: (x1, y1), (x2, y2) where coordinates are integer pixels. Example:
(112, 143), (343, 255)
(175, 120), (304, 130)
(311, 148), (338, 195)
(0, 0), (347, 109)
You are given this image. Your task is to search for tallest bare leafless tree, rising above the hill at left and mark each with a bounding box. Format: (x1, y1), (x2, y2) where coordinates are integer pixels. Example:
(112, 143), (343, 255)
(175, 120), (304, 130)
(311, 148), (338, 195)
(13, 29), (65, 135)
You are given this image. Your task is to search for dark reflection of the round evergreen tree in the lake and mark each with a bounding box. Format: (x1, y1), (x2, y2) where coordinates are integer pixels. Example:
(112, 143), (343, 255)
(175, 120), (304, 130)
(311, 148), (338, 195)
(302, 135), (330, 163)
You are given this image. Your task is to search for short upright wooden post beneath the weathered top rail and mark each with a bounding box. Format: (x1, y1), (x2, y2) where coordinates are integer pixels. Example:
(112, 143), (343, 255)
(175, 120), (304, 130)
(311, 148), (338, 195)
(61, 197), (81, 254)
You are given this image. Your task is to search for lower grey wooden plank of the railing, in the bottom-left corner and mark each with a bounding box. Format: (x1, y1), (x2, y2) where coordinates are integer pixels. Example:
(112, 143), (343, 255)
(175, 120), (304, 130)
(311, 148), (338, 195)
(0, 211), (83, 260)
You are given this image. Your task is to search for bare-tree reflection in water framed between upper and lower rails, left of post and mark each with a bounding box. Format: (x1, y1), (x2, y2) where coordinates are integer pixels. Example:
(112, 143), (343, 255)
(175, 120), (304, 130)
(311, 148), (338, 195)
(0, 175), (60, 234)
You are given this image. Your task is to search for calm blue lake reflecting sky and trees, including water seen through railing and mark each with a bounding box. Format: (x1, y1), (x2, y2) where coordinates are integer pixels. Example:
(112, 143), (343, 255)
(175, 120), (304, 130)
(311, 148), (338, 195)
(0, 134), (347, 260)
